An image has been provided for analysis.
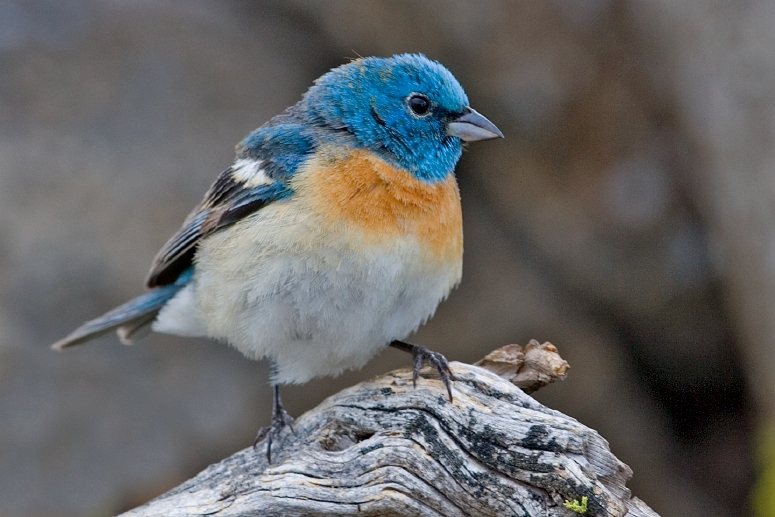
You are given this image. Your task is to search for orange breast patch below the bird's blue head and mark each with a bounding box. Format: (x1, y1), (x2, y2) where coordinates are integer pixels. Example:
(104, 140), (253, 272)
(295, 150), (463, 260)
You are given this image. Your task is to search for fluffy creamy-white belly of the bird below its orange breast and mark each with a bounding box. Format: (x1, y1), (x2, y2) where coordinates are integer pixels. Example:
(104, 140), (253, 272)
(154, 203), (462, 383)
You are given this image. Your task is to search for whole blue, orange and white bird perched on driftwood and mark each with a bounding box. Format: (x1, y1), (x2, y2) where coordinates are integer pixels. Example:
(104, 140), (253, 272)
(52, 54), (503, 463)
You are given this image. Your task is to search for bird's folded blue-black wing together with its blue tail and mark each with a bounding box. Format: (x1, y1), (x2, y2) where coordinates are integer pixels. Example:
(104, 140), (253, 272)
(53, 113), (316, 350)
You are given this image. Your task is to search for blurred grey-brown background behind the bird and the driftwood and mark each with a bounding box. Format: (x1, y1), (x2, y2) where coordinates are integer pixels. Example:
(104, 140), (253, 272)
(0, 0), (775, 517)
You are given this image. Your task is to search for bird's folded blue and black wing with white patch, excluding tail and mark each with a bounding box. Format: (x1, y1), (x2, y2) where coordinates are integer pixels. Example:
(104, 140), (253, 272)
(146, 122), (315, 287)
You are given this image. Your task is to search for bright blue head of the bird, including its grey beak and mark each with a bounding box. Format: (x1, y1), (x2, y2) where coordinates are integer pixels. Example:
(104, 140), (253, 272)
(304, 54), (502, 182)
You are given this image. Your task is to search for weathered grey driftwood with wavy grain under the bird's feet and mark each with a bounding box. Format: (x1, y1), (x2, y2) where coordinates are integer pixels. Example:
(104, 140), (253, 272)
(123, 343), (658, 517)
